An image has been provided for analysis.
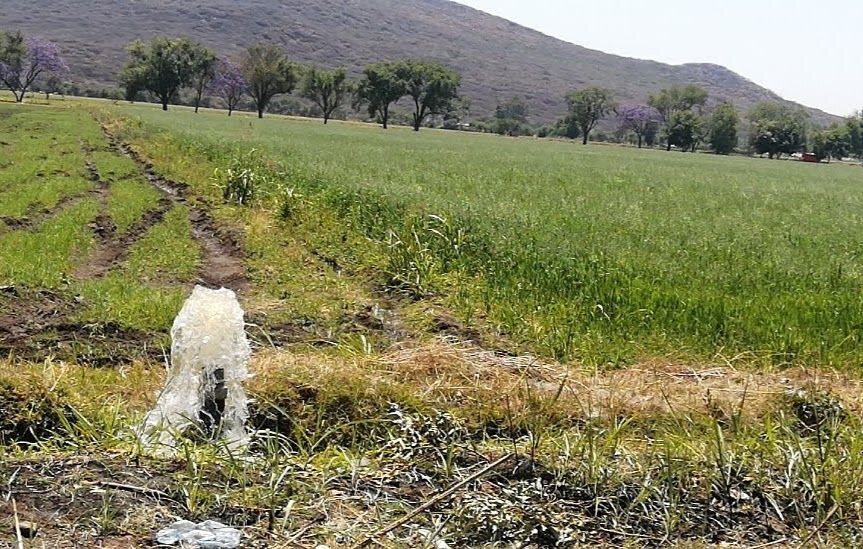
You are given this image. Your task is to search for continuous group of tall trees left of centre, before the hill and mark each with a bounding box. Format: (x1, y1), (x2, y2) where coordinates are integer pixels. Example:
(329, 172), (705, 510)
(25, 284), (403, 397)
(120, 37), (461, 131)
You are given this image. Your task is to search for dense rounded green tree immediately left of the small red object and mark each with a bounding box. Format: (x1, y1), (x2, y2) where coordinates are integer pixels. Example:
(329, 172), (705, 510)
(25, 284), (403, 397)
(749, 103), (809, 159)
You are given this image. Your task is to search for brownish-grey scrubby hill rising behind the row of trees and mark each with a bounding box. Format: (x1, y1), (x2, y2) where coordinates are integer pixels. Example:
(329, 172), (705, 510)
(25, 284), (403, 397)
(0, 0), (834, 122)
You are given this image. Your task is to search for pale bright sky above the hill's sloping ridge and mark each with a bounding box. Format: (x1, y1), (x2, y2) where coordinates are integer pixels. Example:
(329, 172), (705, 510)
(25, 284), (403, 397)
(457, 0), (863, 115)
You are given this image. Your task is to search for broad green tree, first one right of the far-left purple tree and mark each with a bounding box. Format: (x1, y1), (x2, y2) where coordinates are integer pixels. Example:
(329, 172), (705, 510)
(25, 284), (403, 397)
(120, 36), (202, 111)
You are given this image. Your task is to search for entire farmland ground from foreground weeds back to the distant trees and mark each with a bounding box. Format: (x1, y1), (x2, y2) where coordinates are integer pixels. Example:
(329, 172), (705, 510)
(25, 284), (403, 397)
(0, 100), (863, 547)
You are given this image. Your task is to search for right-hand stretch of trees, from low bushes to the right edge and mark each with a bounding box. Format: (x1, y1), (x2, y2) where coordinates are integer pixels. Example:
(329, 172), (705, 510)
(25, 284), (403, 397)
(492, 85), (863, 160)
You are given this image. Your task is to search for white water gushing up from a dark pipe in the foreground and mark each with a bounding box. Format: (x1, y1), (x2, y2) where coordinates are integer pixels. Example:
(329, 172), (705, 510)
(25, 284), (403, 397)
(140, 286), (251, 451)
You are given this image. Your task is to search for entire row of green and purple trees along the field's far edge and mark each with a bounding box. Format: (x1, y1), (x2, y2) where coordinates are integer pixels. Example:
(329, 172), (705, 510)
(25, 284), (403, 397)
(0, 28), (863, 160)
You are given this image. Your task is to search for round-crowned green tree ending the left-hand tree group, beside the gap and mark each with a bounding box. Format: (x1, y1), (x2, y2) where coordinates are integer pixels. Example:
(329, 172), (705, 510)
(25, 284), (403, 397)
(396, 59), (461, 132)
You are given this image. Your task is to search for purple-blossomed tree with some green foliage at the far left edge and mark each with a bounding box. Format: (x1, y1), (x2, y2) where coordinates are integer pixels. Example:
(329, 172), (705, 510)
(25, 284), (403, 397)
(0, 32), (68, 103)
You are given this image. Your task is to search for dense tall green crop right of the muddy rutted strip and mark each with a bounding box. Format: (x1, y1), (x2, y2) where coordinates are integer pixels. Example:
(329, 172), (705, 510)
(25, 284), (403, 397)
(118, 106), (863, 367)
